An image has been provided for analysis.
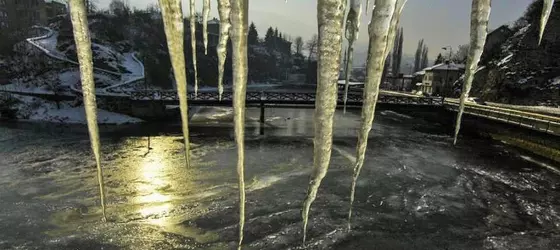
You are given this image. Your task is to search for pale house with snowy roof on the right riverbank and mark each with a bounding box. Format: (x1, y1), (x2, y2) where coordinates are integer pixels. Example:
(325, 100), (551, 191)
(417, 61), (465, 96)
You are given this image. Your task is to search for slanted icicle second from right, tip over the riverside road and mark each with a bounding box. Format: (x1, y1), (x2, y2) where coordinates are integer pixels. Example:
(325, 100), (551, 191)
(453, 0), (492, 145)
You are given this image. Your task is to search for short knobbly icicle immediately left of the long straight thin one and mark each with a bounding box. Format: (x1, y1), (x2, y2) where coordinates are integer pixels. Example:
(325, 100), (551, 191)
(216, 0), (231, 101)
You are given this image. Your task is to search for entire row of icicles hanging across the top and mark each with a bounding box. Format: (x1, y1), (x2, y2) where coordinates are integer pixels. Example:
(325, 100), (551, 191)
(69, 0), (554, 248)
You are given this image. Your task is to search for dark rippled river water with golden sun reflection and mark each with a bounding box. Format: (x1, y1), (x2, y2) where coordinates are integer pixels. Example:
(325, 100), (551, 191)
(0, 108), (560, 249)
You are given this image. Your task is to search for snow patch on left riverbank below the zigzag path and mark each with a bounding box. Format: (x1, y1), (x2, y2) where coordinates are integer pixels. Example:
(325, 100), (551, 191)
(13, 95), (142, 125)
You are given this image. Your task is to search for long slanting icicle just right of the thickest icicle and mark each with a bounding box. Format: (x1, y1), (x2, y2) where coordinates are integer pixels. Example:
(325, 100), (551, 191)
(348, 0), (406, 230)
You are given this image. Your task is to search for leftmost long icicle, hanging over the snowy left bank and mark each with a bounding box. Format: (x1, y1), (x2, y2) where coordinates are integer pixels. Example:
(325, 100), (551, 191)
(69, 0), (107, 221)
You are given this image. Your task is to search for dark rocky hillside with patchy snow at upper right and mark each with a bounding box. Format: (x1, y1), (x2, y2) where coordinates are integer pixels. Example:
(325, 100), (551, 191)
(466, 1), (560, 106)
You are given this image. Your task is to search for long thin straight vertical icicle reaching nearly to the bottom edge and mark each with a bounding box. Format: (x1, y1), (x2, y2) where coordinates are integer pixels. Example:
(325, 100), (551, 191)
(231, 0), (249, 249)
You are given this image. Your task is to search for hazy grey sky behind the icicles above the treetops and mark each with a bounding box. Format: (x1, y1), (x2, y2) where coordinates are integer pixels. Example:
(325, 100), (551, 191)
(96, 0), (532, 61)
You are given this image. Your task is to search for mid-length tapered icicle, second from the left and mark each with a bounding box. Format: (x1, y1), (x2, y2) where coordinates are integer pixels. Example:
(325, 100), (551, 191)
(159, 0), (190, 167)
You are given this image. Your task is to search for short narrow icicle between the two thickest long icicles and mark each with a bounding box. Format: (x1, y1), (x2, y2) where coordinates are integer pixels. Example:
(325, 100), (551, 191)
(343, 0), (362, 114)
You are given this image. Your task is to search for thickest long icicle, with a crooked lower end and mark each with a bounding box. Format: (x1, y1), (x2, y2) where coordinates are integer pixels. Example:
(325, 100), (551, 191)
(301, 0), (346, 244)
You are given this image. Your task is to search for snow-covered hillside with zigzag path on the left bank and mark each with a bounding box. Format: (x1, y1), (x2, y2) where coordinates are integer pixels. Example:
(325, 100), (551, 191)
(0, 16), (144, 124)
